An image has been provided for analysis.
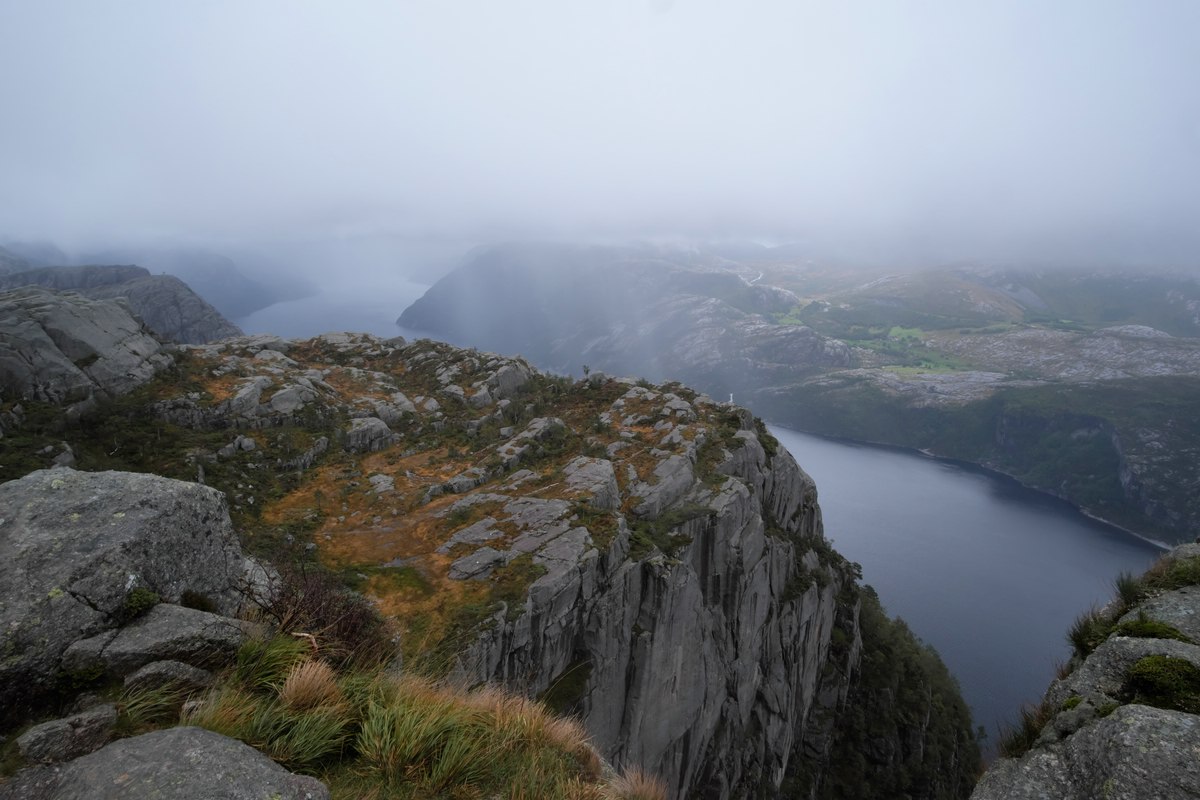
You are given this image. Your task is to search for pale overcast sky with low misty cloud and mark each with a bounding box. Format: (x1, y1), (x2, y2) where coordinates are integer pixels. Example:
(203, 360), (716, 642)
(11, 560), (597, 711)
(0, 0), (1200, 263)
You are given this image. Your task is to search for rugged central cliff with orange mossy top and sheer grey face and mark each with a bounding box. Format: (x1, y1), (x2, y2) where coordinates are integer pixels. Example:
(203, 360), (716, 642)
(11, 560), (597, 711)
(5, 291), (977, 798)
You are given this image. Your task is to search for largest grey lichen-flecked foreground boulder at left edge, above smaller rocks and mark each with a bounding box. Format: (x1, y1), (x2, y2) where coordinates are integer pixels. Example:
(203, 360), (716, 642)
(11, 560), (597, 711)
(0, 468), (246, 716)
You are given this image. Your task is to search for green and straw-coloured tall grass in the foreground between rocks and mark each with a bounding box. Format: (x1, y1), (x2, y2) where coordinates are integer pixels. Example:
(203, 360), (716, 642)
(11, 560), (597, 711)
(189, 636), (619, 800)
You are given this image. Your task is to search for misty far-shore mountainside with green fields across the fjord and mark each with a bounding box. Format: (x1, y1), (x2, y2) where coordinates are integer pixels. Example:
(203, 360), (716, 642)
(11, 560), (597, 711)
(400, 245), (1200, 541)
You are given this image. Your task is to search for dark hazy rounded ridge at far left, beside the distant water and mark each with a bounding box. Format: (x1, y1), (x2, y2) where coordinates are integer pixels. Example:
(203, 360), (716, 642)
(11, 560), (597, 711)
(0, 266), (241, 344)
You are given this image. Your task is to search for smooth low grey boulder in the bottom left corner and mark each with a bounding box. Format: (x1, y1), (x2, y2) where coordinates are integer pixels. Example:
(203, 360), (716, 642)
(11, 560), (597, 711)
(0, 728), (329, 800)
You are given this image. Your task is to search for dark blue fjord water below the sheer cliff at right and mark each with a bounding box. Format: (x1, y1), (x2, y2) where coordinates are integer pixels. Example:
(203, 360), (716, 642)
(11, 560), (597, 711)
(770, 426), (1163, 744)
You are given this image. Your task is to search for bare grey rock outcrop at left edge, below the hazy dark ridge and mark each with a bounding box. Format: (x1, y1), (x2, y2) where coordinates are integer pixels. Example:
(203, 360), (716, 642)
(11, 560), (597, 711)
(0, 287), (172, 411)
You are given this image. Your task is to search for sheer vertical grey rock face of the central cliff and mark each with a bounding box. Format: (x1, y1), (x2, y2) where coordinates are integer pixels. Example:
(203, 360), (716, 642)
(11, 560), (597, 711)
(454, 398), (851, 798)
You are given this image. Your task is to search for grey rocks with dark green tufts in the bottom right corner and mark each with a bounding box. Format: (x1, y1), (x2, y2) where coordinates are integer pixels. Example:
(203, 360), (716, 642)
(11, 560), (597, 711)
(971, 545), (1200, 800)
